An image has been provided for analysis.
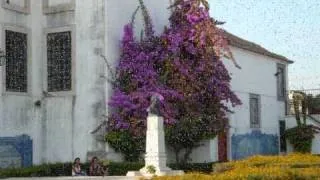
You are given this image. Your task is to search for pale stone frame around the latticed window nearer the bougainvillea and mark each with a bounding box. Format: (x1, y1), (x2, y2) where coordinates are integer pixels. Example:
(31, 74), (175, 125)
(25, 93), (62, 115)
(43, 25), (76, 96)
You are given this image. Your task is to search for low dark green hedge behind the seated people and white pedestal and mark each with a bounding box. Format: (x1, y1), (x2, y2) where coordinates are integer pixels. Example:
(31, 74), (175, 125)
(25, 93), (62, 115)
(0, 162), (213, 178)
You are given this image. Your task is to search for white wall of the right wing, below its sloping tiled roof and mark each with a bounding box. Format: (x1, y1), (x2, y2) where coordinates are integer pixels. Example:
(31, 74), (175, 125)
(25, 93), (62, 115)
(188, 47), (285, 162)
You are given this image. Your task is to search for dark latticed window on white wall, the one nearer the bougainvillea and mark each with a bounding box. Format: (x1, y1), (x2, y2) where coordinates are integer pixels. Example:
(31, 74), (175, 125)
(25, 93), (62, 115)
(47, 31), (72, 92)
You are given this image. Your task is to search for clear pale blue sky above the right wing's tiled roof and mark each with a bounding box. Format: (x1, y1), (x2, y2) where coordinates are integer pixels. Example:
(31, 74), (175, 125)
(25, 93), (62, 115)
(209, 0), (320, 89)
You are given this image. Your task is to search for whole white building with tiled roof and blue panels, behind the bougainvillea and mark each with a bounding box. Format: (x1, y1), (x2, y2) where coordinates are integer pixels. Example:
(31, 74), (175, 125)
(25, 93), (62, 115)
(0, 0), (302, 167)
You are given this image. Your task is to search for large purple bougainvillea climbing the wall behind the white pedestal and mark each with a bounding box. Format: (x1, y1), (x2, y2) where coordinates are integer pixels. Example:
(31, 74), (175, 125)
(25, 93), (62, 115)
(107, 0), (241, 162)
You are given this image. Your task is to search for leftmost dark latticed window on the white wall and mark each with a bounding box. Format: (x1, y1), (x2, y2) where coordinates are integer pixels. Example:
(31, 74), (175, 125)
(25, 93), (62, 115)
(5, 30), (28, 92)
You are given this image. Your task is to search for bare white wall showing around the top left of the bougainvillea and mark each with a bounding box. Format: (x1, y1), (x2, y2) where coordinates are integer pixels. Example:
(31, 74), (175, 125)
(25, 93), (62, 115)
(105, 0), (169, 97)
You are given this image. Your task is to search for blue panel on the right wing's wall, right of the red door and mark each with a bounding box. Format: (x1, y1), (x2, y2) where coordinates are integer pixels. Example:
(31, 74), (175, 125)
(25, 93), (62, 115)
(231, 130), (279, 160)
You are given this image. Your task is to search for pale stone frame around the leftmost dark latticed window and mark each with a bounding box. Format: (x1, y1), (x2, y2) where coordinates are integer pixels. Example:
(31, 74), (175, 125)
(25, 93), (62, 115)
(1, 24), (32, 96)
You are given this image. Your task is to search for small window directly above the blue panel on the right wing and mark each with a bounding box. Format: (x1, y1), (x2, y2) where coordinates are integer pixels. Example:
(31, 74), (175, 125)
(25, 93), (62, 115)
(250, 94), (261, 128)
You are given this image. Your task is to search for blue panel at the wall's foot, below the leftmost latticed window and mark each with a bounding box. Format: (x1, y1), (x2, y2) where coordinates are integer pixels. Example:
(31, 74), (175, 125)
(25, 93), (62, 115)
(0, 135), (32, 168)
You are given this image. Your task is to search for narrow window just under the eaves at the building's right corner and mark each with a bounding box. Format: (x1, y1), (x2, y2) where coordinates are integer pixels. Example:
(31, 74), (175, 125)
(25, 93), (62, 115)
(277, 64), (286, 101)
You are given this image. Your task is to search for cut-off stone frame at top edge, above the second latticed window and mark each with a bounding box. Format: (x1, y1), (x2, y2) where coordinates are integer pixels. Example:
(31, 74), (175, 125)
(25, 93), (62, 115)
(42, 0), (76, 15)
